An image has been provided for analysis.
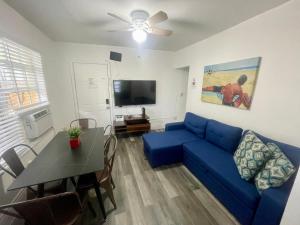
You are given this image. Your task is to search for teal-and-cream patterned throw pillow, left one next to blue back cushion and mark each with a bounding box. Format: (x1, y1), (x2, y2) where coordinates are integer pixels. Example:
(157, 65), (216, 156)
(234, 131), (271, 180)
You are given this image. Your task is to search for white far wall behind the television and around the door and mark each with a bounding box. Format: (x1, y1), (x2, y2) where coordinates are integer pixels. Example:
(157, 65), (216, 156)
(57, 43), (182, 128)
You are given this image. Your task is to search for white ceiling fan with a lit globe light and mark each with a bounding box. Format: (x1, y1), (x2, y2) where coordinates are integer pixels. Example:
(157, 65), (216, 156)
(107, 10), (172, 43)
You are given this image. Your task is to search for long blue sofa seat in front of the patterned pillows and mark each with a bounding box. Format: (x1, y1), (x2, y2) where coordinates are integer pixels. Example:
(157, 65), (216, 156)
(183, 140), (260, 209)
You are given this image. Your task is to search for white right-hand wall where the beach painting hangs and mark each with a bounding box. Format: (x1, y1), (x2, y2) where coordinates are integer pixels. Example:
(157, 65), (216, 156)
(174, 0), (300, 225)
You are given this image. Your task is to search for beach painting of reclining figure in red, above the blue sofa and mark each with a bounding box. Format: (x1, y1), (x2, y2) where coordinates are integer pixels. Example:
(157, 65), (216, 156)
(201, 57), (261, 109)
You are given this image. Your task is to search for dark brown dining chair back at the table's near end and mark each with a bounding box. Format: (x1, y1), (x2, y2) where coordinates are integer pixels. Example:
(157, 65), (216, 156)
(0, 192), (87, 225)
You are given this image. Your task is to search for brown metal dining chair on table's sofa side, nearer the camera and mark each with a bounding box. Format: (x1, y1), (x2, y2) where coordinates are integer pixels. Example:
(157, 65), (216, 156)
(77, 135), (118, 208)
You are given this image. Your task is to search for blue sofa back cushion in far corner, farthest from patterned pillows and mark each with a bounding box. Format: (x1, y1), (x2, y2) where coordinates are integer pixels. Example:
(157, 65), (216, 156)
(184, 112), (208, 138)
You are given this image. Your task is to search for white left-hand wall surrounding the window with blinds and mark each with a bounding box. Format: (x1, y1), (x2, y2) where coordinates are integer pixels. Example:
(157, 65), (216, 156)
(0, 0), (58, 224)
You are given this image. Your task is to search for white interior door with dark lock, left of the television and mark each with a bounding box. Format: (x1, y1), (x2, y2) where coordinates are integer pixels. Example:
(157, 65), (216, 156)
(73, 63), (111, 127)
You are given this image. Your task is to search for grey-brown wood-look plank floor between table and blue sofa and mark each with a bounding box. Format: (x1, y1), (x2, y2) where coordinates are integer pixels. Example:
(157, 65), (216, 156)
(83, 137), (239, 225)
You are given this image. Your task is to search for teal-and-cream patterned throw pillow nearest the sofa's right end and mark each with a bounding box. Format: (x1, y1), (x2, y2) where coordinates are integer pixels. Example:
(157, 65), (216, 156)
(255, 143), (296, 191)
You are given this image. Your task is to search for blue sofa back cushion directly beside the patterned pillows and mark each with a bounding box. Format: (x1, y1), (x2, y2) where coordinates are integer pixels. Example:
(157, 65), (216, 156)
(205, 120), (243, 154)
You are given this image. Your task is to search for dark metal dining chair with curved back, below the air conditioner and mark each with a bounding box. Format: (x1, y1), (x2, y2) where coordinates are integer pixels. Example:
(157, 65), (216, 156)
(0, 144), (66, 198)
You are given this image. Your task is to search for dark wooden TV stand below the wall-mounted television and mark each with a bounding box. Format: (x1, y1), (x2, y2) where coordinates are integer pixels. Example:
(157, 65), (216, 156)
(114, 115), (151, 134)
